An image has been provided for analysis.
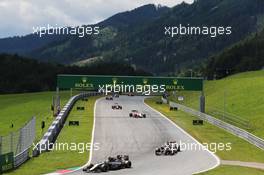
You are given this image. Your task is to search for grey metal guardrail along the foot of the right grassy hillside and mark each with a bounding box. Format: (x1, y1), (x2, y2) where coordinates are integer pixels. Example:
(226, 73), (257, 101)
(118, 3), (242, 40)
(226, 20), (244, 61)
(169, 102), (264, 150)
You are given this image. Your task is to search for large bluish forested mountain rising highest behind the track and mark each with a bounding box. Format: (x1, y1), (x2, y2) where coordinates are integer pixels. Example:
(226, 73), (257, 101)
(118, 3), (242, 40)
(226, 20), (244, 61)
(0, 0), (264, 74)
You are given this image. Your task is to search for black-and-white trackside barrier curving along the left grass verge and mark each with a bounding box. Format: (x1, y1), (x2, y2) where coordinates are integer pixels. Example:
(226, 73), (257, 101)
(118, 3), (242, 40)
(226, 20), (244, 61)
(33, 92), (100, 156)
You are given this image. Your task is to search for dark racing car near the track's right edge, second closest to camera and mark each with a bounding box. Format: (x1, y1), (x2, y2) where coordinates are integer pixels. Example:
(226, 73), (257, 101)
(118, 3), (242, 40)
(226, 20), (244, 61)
(155, 141), (181, 156)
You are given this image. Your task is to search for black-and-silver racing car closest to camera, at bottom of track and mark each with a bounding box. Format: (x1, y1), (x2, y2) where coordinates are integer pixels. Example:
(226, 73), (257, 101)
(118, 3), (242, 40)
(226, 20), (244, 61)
(83, 155), (132, 173)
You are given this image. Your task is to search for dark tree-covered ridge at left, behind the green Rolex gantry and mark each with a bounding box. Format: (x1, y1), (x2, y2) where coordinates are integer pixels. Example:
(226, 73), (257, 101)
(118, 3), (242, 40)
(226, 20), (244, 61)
(0, 54), (150, 94)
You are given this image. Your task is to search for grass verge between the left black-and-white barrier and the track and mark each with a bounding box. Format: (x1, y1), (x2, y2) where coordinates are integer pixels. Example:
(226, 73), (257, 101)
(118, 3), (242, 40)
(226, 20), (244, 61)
(6, 97), (99, 175)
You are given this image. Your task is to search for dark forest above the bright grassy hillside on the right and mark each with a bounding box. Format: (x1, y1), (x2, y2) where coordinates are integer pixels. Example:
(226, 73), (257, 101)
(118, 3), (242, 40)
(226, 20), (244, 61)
(203, 30), (264, 79)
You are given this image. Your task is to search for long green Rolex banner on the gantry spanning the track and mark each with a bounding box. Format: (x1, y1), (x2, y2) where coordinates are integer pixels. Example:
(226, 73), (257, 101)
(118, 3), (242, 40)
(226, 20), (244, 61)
(57, 75), (203, 91)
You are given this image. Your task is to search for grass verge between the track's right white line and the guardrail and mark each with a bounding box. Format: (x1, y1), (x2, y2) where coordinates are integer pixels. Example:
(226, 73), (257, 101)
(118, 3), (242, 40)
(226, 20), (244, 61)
(145, 97), (264, 162)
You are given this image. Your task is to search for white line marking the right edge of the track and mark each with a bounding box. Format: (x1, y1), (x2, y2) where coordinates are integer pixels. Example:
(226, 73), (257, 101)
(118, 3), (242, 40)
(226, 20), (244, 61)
(143, 99), (220, 174)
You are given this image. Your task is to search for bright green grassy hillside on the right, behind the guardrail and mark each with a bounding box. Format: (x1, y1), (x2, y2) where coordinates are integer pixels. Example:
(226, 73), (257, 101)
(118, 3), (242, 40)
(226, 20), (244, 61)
(170, 71), (264, 138)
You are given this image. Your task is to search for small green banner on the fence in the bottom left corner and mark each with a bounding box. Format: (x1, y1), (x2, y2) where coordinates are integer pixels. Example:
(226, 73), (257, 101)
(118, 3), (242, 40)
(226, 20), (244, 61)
(0, 152), (14, 173)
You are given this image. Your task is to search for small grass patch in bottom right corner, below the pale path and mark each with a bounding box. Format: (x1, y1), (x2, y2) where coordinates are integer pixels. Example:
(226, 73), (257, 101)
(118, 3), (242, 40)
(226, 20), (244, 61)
(200, 165), (264, 175)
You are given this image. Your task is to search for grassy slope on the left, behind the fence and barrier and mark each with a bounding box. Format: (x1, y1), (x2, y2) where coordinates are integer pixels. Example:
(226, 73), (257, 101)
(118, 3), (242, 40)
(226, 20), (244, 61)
(0, 92), (70, 138)
